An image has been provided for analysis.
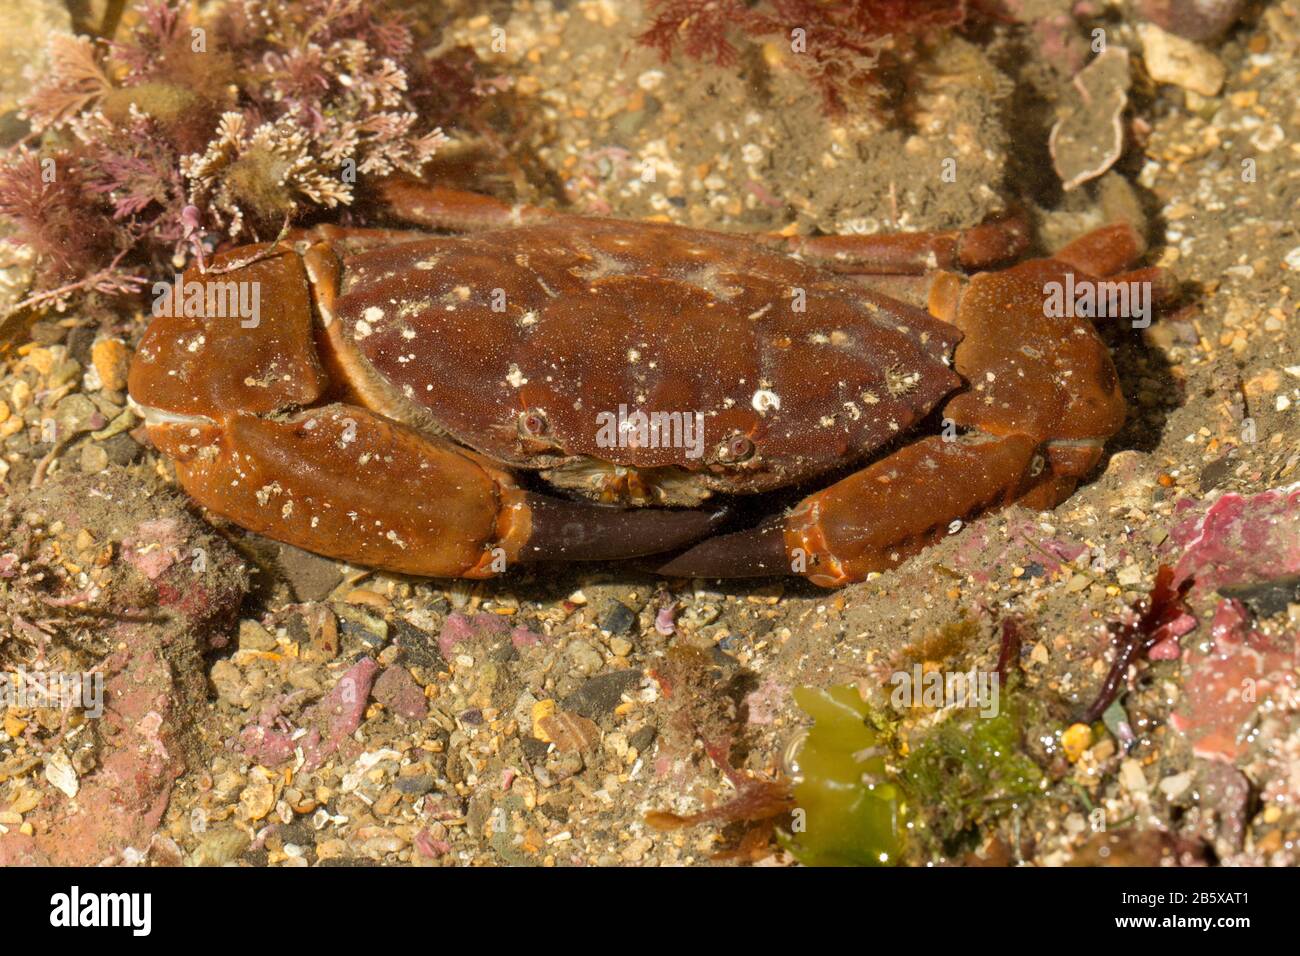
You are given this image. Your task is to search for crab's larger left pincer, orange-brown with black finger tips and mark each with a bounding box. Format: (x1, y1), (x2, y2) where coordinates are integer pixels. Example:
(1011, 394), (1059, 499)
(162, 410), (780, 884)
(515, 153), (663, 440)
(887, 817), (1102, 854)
(150, 405), (733, 578)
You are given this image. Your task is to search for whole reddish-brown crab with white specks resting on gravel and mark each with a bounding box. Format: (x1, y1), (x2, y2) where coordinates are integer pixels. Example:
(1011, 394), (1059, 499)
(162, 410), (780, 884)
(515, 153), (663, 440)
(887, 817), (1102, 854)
(129, 179), (1169, 587)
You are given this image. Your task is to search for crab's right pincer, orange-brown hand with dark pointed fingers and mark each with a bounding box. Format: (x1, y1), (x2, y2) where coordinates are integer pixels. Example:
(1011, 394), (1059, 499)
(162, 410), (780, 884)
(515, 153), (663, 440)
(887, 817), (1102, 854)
(659, 434), (1043, 588)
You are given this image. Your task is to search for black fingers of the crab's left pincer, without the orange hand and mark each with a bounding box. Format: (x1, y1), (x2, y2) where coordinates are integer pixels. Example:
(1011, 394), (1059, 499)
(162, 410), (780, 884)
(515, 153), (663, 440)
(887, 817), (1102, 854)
(516, 494), (727, 562)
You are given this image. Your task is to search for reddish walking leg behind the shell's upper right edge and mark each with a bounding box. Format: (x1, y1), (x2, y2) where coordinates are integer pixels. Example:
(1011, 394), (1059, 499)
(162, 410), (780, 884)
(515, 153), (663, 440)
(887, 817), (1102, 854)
(764, 205), (1030, 276)
